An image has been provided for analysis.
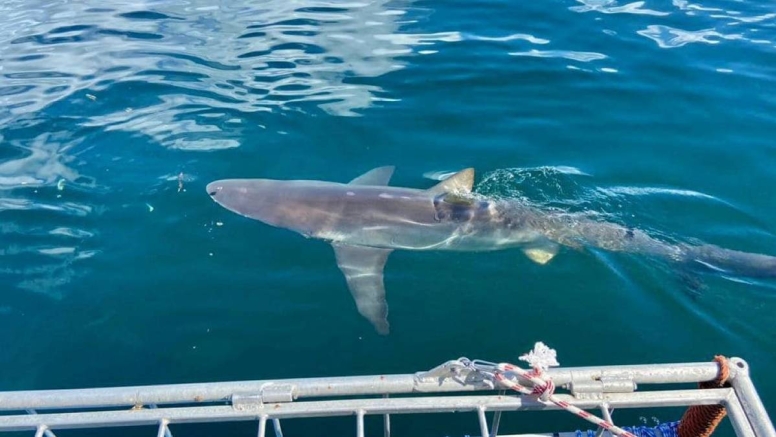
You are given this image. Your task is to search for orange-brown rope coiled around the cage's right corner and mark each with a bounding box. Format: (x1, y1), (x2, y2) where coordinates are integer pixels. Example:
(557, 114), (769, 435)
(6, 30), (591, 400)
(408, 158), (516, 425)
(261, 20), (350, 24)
(677, 355), (730, 437)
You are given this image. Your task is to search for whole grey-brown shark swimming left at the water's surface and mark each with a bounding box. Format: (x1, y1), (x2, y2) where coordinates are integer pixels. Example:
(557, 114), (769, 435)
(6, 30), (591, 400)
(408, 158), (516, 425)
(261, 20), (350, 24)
(207, 166), (776, 334)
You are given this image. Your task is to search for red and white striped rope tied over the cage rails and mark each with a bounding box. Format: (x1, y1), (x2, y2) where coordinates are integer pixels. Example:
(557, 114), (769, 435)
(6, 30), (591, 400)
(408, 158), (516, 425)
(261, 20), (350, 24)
(494, 363), (636, 437)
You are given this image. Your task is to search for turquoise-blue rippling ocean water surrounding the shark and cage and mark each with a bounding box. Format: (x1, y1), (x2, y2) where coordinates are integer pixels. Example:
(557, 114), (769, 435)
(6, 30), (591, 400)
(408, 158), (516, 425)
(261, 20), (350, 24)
(0, 0), (776, 436)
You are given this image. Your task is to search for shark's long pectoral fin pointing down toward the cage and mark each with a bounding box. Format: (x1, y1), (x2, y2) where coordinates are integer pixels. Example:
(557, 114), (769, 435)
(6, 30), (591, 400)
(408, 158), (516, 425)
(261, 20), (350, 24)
(333, 244), (391, 335)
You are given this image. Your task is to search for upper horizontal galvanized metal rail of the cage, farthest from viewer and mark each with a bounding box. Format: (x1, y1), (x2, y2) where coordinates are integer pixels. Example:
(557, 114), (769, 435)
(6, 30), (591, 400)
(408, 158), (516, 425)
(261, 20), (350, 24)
(0, 362), (718, 411)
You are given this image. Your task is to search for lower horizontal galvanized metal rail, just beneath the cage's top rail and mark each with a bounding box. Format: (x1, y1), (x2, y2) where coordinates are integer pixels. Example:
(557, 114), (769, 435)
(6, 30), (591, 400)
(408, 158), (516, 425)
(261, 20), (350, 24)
(0, 388), (732, 435)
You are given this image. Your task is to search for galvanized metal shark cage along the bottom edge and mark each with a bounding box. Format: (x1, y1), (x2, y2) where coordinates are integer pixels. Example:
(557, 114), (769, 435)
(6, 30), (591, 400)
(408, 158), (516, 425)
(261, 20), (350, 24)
(0, 358), (776, 437)
